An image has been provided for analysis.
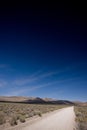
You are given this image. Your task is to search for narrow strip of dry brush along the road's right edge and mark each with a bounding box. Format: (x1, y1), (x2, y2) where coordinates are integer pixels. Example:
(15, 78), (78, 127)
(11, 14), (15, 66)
(75, 106), (87, 130)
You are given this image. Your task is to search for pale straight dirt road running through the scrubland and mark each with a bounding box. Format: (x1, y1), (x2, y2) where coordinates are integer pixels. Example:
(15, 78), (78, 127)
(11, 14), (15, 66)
(21, 107), (75, 130)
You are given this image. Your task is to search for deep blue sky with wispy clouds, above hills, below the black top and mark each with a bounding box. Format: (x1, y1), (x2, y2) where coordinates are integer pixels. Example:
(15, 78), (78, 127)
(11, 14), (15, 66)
(0, 6), (87, 101)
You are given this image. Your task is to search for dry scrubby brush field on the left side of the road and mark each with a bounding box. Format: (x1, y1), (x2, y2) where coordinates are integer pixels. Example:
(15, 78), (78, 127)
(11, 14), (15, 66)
(0, 102), (66, 126)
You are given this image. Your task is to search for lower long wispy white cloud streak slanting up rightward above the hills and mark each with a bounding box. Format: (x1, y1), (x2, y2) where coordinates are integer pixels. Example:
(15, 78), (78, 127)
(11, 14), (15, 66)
(4, 75), (82, 96)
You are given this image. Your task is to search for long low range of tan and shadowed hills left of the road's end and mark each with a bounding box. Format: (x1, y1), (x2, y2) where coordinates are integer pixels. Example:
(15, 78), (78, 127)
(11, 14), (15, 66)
(0, 96), (74, 105)
